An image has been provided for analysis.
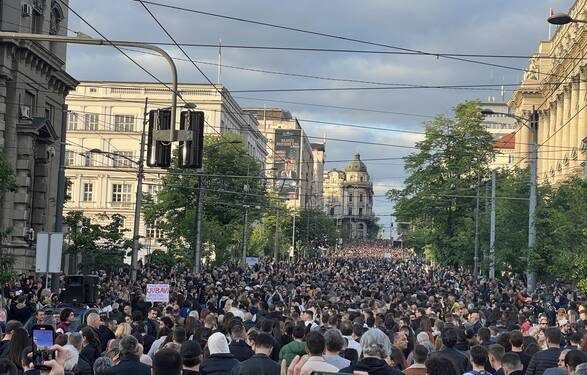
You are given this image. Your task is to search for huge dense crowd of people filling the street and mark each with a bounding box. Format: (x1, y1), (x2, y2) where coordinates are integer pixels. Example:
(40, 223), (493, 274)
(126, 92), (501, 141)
(0, 244), (587, 375)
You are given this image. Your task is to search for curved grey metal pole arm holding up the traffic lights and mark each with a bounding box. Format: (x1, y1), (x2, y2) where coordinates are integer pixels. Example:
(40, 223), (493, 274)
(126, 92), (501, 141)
(0, 31), (177, 135)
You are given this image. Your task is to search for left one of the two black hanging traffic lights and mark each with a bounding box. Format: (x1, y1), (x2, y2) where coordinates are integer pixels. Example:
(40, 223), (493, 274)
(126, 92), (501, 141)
(147, 109), (171, 168)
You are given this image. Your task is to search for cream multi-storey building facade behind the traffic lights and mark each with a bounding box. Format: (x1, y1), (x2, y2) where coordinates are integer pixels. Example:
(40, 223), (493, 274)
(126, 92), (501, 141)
(65, 81), (266, 257)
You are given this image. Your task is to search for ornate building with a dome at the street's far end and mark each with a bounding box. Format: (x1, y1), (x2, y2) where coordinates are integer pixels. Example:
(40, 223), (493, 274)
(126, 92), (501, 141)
(323, 153), (377, 241)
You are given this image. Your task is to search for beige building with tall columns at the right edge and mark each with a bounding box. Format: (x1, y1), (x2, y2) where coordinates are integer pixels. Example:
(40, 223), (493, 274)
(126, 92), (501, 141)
(509, 0), (587, 183)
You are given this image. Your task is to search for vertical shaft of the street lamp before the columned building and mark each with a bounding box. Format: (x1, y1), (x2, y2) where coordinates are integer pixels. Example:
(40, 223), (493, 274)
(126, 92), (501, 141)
(527, 109), (538, 292)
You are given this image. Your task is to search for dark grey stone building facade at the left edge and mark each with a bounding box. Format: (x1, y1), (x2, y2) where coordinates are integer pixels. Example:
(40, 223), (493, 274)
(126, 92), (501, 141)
(0, 0), (77, 271)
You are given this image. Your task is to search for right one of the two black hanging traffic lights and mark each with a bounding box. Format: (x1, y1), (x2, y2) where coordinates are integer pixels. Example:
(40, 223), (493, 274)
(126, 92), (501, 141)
(179, 111), (204, 168)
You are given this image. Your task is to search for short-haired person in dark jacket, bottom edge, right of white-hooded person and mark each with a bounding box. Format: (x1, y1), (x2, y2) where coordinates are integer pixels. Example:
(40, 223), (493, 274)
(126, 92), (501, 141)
(231, 333), (281, 375)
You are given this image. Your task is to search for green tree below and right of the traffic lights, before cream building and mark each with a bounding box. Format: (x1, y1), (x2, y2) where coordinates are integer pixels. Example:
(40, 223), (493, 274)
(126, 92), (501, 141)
(143, 133), (266, 265)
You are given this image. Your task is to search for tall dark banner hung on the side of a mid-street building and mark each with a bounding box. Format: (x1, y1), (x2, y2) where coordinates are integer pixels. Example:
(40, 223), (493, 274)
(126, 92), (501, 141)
(273, 129), (301, 199)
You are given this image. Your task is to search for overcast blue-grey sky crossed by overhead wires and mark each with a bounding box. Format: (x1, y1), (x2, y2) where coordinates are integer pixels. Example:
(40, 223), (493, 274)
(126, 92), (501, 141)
(67, 0), (573, 233)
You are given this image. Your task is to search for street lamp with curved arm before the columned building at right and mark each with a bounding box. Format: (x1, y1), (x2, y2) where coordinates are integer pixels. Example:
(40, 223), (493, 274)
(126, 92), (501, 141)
(481, 107), (536, 292)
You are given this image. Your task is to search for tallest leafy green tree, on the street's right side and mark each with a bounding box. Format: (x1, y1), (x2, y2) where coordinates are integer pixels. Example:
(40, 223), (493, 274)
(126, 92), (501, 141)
(387, 102), (494, 264)
